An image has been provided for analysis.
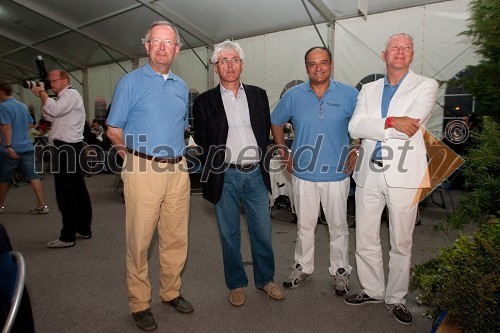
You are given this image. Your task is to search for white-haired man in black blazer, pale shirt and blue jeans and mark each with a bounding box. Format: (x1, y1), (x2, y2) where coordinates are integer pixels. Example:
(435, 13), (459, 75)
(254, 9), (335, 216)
(193, 40), (284, 306)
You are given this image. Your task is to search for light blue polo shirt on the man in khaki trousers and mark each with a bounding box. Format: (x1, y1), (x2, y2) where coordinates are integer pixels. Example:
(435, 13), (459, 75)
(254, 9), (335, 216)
(107, 63), (189, 157)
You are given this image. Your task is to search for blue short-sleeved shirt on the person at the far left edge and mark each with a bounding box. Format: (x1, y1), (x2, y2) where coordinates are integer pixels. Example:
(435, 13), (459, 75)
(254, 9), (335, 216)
(0, 98), (33, 153)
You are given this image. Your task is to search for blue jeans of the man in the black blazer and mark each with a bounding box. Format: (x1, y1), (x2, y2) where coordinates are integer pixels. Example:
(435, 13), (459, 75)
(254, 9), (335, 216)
(215, 167), (274, 290)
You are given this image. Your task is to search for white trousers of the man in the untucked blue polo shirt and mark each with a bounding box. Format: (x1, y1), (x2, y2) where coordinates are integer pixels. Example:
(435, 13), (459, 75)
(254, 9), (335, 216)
(292, 176), (352, 275)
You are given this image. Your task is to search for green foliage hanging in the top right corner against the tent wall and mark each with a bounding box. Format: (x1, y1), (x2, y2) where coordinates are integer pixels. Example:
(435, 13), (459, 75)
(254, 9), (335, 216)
(456, 0), (500, 122)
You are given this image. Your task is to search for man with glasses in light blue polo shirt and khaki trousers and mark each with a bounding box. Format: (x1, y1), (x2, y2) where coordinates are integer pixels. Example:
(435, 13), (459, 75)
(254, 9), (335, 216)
(107, 21), (193, 331)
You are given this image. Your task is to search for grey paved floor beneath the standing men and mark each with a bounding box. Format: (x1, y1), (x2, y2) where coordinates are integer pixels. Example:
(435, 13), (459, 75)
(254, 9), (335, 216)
(0, 174), (466, 333)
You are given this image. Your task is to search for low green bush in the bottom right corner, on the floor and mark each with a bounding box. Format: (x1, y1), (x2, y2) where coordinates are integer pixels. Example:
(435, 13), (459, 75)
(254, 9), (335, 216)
(410, 218), (500, 332)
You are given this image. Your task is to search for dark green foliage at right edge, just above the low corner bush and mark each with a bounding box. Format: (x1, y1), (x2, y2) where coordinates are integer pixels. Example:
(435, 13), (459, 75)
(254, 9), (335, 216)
(447, 117), (500, 229)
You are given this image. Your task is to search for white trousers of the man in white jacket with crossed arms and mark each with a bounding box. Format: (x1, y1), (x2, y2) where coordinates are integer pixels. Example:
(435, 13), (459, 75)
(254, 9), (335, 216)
(356, 172), (418, 304)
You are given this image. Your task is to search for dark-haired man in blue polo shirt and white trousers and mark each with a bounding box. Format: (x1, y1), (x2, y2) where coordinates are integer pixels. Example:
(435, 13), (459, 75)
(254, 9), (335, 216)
(271, 47), (358, 296)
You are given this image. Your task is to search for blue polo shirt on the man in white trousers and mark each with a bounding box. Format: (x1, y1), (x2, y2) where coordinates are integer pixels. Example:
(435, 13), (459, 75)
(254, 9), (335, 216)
(271, 79), (358, 182)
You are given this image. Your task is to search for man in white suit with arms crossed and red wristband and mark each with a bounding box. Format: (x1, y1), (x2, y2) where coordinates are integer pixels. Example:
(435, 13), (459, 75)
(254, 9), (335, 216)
(345, 33), (438, 324)
